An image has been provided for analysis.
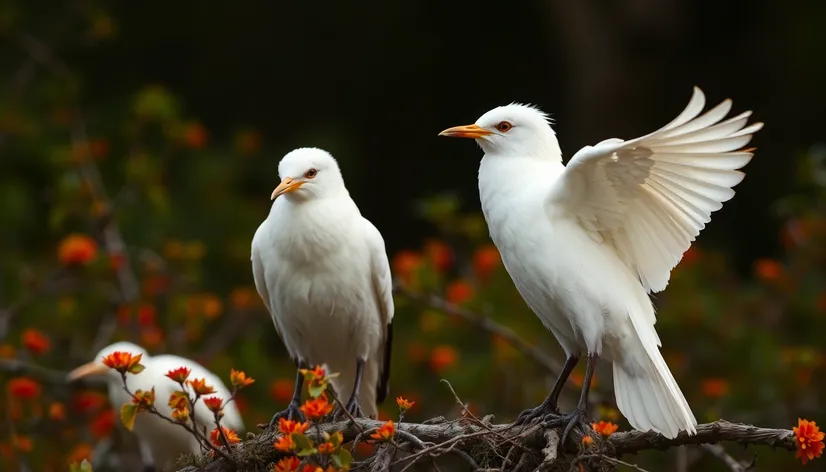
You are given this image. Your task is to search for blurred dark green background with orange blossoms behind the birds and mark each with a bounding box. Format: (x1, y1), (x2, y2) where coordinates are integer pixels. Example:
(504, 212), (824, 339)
(0, 0), (826, 471)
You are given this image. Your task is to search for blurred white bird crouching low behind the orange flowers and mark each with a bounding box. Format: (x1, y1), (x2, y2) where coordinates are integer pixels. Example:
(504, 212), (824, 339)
(68, 342), (244, 472)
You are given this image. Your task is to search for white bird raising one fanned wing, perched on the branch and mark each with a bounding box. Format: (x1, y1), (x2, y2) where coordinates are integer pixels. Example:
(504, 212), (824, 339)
(440, 87), (763, 438)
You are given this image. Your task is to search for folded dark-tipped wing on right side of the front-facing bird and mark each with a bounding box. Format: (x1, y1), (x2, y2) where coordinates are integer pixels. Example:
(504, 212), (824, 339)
(364, 219), (394, 403)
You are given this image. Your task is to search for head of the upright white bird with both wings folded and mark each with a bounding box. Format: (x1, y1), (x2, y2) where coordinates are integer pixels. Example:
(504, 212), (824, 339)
(270, 148), (347, 201)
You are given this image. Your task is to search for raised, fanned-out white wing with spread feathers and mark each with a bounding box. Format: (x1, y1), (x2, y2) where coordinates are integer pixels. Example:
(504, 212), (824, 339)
(549, 87), (763, 292)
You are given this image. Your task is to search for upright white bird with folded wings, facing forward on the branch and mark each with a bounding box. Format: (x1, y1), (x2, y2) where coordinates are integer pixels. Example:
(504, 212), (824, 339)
(251, 148), (393, 427)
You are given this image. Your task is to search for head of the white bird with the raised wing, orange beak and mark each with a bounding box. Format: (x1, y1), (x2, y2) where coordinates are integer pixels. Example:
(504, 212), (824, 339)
(439, 103), (561, 159)
